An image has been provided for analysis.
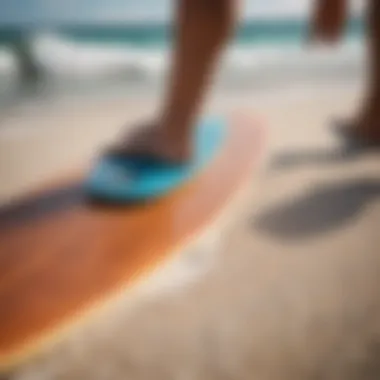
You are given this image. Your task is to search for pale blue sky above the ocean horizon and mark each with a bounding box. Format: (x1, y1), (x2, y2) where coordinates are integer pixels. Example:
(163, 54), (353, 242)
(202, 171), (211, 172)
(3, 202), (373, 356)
(0, 0), (361, 25)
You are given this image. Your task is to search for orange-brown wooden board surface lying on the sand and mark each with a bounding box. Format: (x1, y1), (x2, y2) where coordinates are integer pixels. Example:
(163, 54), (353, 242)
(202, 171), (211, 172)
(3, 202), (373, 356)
(0, 119), (263, 368)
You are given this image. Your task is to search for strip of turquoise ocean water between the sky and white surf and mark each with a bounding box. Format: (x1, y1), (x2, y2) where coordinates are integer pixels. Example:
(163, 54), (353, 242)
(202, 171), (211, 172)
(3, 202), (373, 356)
(0, 18), (363, 47)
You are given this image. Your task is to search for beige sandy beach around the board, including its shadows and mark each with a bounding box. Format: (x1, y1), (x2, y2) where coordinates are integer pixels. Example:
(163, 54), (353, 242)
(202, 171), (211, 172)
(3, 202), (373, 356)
(0, 78), (380, 380)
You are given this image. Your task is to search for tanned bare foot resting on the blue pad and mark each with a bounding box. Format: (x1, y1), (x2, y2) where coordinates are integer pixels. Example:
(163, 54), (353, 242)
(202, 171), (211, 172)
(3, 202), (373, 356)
(109, 123), (191, 164)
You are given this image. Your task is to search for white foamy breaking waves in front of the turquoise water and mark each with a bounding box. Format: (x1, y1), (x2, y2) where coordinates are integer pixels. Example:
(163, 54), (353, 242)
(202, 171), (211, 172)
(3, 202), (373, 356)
(0, 34), (364, 86)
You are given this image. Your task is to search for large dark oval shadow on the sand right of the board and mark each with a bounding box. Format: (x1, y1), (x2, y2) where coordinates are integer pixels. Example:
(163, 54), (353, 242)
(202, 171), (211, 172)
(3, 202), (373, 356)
(252, 179), (380, 239)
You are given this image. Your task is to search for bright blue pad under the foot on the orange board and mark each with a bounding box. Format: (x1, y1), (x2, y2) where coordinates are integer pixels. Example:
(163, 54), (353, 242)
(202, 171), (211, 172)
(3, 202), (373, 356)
(85, 118), (227, 202)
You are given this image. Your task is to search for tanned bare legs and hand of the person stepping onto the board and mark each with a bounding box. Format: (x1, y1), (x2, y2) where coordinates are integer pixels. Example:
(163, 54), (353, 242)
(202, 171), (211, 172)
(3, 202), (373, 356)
(114, 0), (380, 163)
